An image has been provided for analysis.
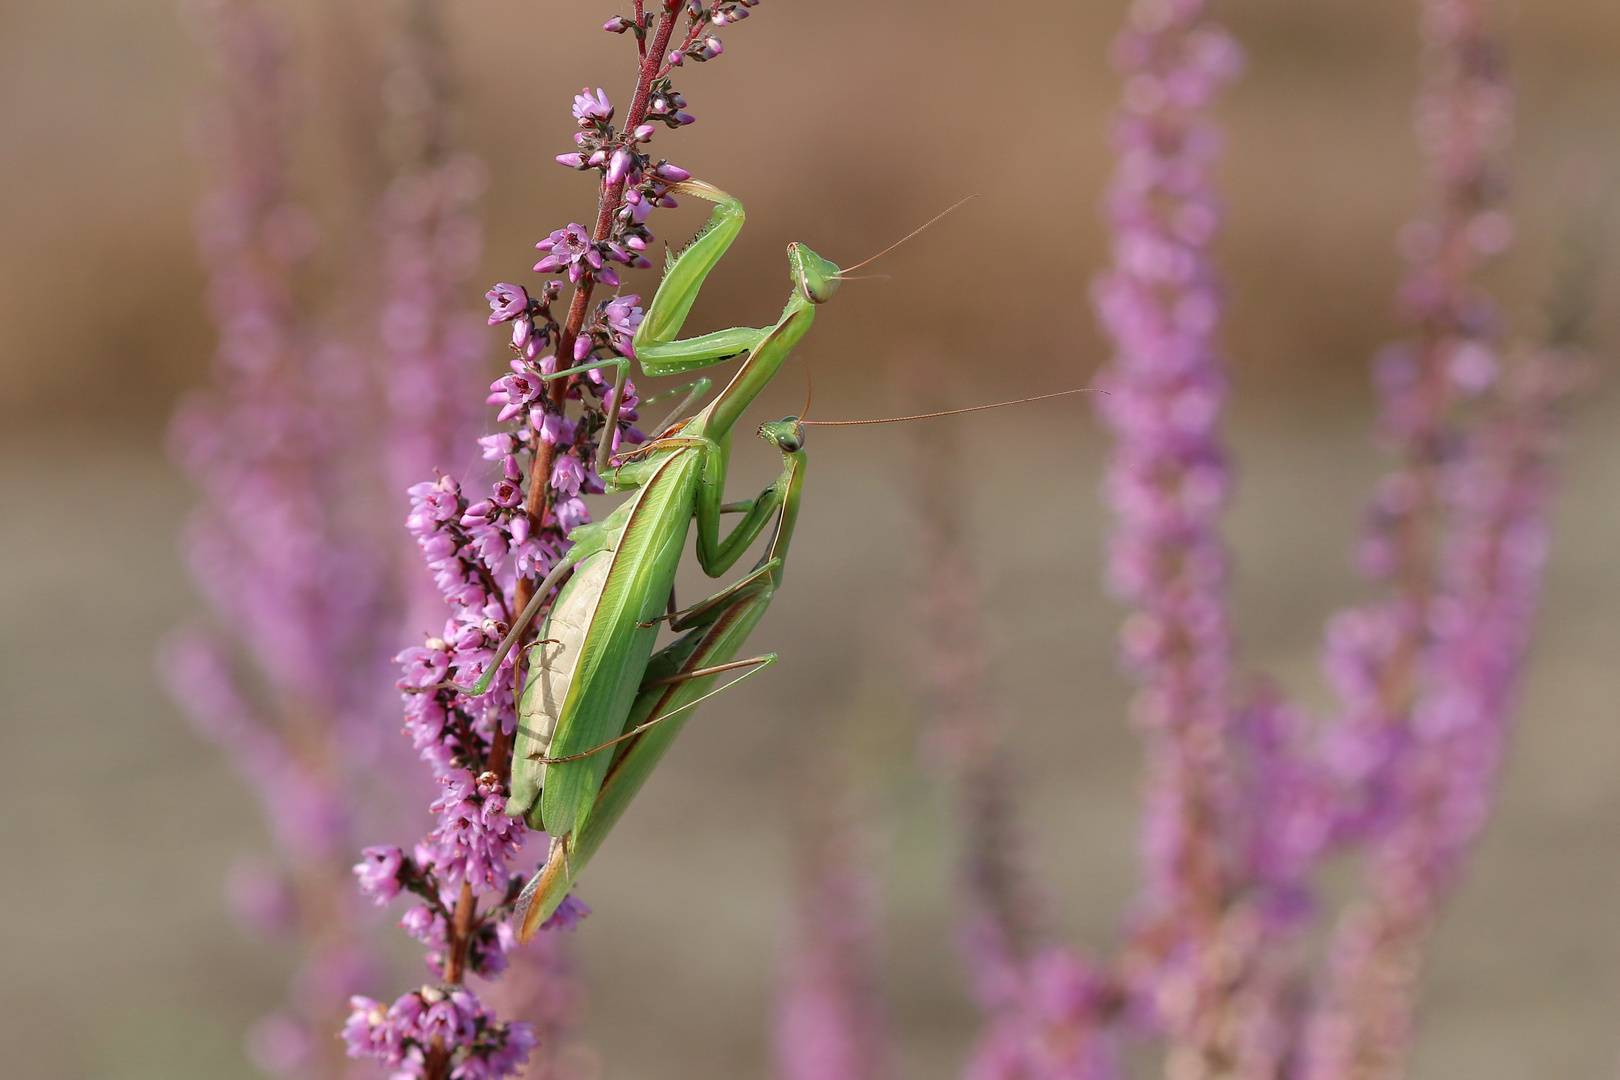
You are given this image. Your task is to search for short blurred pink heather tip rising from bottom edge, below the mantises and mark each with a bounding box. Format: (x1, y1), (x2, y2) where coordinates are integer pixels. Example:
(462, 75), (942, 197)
(774, 771), (894, 1080)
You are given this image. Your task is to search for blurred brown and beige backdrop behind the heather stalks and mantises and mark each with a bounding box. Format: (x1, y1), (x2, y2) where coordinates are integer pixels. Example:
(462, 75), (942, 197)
(0, 0), (1620, 1080)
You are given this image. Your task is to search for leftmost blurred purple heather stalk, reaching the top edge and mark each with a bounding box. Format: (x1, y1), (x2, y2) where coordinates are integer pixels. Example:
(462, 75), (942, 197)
(164, 0), (395, 1077)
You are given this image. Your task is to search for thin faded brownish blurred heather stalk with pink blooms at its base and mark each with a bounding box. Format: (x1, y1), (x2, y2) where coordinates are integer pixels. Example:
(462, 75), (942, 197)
(912, 404), (1119, 1080)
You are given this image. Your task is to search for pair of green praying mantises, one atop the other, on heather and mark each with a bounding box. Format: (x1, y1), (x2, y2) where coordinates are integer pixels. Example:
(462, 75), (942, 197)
(462, 180), (1076, 941)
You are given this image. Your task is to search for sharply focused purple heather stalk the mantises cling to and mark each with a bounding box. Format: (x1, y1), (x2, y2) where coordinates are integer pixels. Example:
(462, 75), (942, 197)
(343, 0), (758, 1080)
